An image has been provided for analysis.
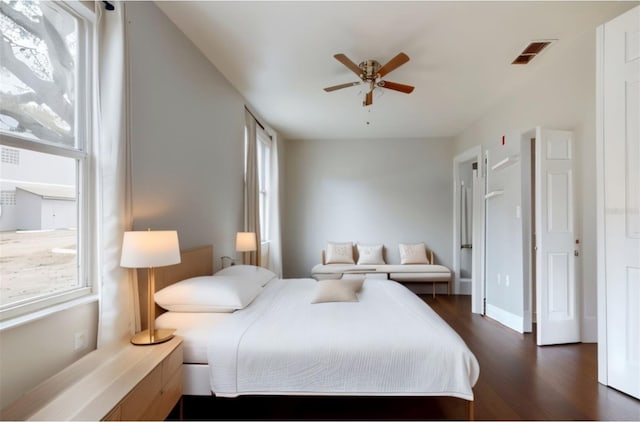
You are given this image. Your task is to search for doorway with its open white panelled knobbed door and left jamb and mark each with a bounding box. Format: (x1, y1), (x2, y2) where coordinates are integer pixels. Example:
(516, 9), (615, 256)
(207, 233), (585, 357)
(520, 127), (580, 345)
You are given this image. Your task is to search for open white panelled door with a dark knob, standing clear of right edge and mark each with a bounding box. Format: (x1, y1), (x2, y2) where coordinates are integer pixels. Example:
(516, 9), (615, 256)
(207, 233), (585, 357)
(536, 128), (580, 345)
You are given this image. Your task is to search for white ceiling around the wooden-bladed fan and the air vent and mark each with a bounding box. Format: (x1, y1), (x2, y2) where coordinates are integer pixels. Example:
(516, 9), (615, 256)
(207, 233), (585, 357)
(156, 1), (638, 139)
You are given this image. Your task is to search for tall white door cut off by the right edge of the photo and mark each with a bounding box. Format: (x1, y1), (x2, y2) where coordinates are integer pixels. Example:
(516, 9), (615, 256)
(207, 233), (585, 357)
(602, 7), (640, 398)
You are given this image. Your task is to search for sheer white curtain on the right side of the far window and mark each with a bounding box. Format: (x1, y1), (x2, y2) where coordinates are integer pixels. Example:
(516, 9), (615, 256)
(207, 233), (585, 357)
(266, 135), (282, 277)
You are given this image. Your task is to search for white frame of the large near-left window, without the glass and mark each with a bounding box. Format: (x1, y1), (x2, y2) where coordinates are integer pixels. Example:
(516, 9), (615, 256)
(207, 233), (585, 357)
(0, 1), (97, 328)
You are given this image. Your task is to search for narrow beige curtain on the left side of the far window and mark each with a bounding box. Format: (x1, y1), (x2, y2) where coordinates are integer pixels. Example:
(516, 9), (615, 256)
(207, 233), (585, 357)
(244, 109), (262, 266)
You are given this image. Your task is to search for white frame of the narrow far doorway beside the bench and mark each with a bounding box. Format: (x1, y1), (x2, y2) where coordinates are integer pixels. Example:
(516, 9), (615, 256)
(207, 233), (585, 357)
(452, 145), (484, 313)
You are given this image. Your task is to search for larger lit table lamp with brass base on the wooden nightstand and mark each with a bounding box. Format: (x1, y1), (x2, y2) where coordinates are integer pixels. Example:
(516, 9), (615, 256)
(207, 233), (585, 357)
(120, 230), (180, 345)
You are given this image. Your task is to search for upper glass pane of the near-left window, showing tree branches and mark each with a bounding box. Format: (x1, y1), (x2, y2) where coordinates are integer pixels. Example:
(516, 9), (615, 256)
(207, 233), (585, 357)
(0, 0), (79, 147)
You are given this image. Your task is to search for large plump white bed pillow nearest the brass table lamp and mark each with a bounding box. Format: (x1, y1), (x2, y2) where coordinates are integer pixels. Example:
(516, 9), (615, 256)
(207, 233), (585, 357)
(154, 275), (262, 312)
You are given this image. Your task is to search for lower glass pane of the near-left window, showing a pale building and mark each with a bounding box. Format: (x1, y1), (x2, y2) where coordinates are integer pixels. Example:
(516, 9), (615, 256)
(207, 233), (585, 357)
(0, 149), (78, 305)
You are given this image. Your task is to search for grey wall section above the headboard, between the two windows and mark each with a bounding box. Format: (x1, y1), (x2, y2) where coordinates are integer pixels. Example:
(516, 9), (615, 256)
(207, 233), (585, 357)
(127, 2), (244, 267)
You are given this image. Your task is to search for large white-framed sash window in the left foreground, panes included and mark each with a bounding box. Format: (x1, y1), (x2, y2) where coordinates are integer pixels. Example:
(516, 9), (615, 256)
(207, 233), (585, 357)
(0, 0), (93, 319)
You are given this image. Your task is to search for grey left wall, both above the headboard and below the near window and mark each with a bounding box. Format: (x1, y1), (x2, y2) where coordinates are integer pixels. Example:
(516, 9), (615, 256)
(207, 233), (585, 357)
(0, 2), (255, 407)
